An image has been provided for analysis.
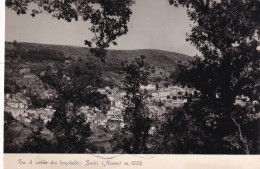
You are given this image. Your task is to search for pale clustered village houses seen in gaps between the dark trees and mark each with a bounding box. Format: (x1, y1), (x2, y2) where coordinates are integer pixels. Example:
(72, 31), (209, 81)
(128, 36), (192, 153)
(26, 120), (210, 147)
(5, 82), (193, 130)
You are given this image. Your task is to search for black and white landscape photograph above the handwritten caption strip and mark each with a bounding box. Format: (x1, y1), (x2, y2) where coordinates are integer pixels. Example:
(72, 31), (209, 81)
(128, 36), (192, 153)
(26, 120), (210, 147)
(3, 0), (260, 155)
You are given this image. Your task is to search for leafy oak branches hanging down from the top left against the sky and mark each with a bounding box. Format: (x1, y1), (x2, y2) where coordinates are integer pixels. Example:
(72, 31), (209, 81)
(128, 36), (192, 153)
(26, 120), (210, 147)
(5, 0), (134, 60)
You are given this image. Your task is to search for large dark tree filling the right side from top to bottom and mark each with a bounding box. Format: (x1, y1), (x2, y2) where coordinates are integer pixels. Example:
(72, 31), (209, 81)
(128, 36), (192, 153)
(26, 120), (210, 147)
(170, 0), (260, 153)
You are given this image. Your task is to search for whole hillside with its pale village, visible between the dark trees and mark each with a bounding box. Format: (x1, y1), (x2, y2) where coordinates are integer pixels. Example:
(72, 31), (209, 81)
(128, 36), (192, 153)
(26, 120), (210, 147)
(4, 42), (260, 153)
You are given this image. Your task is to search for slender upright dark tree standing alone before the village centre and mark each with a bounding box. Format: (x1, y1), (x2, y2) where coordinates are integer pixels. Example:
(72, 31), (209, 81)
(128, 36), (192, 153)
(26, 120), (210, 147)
(114, 56), (151, 154)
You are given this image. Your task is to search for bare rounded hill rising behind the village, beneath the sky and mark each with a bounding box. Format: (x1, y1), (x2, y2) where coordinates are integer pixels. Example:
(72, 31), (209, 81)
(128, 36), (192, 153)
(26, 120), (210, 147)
(5, 42), (192, 85)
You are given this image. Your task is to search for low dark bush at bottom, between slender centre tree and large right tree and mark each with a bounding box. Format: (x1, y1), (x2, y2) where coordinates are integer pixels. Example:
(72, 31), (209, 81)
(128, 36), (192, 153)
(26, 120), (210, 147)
(149, 108), (208, 154)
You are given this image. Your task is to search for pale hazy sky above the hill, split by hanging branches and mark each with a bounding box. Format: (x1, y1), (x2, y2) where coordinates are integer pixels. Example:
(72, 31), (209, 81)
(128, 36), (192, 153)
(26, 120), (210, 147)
(5, 0), (197, 55)
